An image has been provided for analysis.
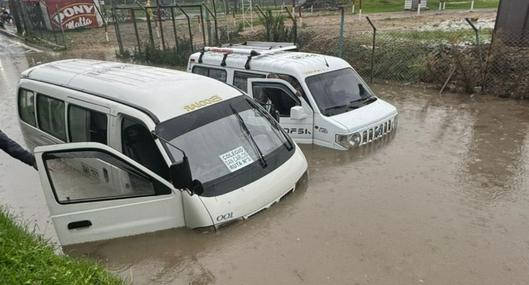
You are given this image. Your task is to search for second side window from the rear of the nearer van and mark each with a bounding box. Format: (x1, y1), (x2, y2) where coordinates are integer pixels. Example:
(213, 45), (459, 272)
(37, 94), (66, 141)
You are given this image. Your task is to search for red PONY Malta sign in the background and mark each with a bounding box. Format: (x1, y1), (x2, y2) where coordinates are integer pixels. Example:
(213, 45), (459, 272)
(46, 0), (100, 30)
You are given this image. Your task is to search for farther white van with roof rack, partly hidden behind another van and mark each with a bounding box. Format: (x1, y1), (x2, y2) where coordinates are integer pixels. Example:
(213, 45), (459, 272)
(187, 42), (398, 150)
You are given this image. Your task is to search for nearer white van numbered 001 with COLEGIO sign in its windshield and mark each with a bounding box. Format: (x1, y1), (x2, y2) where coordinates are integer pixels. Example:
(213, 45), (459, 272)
(18, 60), (307, 245)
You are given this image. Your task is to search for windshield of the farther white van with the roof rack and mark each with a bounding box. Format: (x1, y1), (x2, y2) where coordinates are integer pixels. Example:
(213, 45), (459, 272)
(305, 68), (377, 116)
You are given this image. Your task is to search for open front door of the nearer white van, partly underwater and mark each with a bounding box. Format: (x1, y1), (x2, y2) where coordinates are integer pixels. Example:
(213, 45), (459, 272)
(35, 143), (185, 245)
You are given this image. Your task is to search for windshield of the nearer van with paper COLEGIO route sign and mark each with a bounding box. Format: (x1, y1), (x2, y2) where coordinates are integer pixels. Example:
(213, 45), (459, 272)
(156, 95), (293, 197)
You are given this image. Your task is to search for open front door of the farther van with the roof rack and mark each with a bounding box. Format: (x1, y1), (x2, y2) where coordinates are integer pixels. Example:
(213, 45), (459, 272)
(248, 78), (314, 144)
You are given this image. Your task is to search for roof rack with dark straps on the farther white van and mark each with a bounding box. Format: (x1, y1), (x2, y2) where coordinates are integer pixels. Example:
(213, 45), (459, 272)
(198, 41), (298, 69)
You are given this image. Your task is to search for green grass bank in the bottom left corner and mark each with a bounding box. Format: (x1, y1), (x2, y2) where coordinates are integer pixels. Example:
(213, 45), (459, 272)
(0, 208), (123, 284)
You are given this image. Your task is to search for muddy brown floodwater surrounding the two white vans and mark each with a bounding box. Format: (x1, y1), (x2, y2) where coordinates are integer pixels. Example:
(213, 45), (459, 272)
(0, 32), (529, 284)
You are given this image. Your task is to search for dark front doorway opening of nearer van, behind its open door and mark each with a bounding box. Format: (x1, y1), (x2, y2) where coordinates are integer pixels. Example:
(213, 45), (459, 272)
(121, 117), (169, 179)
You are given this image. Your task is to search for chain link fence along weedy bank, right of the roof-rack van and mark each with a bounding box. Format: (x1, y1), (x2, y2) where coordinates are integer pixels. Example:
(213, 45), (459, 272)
(298, 14), (529, 98)
